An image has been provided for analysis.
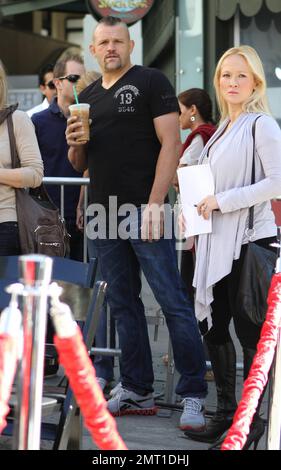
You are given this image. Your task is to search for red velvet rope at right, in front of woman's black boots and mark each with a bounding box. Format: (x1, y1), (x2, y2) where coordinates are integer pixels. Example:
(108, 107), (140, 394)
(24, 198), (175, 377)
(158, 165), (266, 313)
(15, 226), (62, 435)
(221, 273), (281, 450)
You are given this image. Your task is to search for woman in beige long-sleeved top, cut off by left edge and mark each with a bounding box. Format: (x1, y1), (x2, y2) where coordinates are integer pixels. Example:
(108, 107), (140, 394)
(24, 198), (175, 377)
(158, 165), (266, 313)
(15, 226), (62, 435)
(0, 61), (43, 256)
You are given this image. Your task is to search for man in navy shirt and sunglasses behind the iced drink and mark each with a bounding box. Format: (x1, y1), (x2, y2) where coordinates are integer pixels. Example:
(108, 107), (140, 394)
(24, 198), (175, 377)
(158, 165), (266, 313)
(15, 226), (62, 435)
(32, 55), (85, 261)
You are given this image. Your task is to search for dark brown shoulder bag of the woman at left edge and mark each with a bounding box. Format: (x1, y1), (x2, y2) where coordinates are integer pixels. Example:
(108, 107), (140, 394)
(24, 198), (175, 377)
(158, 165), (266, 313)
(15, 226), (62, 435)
(7, 107), (69, 256)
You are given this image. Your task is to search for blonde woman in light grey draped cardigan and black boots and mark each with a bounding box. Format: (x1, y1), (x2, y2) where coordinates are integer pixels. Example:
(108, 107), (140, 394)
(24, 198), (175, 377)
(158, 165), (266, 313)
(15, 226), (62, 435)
(186, 46), (281, 449)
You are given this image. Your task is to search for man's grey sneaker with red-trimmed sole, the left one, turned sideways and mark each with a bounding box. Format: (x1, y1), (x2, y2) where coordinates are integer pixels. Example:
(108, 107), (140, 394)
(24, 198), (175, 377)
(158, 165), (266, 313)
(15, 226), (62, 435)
(107, 386), (157, 416)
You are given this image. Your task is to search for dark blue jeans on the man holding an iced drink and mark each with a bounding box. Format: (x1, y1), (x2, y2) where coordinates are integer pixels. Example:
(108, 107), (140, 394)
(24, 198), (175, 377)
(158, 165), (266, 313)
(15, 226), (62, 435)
(95, 208), (207, 397)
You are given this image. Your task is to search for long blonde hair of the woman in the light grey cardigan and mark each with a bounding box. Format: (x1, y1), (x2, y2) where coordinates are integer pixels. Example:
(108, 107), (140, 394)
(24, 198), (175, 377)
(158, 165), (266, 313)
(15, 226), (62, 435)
(214, 46), (271, 121)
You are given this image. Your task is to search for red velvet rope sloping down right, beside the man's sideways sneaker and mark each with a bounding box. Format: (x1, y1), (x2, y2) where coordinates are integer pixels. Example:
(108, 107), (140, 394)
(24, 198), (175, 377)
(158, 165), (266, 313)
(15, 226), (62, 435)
(54, 327), (127, 450)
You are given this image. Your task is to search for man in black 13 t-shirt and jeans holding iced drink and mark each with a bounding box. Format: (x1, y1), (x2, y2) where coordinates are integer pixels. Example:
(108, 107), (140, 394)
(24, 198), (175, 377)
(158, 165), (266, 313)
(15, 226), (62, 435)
(66, 17), (207, 430)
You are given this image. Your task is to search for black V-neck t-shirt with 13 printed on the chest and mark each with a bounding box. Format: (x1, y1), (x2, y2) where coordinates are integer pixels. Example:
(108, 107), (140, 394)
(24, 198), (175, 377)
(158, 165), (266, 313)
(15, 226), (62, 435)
(79, 66), (178, 206)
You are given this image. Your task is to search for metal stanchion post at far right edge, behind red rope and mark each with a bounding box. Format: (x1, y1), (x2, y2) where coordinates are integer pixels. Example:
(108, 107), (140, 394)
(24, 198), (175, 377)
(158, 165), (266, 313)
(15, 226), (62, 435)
(267, 227), (281, 450)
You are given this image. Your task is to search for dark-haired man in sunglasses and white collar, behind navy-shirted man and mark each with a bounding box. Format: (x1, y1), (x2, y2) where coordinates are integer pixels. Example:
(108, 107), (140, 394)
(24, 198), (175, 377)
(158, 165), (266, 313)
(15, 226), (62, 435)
(27, 64), (56, 117)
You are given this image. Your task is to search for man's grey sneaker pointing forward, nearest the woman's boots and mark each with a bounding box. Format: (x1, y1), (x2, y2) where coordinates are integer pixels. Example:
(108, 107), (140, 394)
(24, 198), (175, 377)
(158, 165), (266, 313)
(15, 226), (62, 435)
(180, 397), (206, 431)
